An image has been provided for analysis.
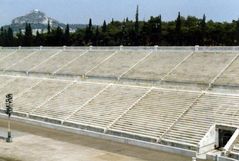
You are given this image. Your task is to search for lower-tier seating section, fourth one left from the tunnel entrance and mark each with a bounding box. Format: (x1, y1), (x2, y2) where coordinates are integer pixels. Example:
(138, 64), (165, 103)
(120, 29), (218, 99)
(31, 83), (105, 120)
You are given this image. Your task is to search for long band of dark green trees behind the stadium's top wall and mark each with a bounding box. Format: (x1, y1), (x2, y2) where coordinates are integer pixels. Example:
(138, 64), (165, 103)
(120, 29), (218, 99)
(0, 9), (239, 46)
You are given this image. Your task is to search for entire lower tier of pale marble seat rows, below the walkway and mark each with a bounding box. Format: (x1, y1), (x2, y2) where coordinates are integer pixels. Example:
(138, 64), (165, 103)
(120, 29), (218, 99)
(0, 76), (239, 152)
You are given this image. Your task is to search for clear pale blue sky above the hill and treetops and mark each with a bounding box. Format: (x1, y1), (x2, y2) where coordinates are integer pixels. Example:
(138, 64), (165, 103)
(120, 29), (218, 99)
(0, 0), (239, 26)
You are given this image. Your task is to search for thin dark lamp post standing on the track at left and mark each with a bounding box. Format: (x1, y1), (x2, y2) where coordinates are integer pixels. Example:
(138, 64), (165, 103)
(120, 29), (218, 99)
(6, 94), (13, 143)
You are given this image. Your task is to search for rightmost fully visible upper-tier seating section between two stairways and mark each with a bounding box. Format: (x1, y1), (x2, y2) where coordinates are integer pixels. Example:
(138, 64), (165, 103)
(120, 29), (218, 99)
(165, 52), (236, 84)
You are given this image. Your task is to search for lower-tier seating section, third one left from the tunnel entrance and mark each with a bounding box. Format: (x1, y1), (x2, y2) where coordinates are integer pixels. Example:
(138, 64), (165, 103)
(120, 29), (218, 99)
(67, 85), (146, 130)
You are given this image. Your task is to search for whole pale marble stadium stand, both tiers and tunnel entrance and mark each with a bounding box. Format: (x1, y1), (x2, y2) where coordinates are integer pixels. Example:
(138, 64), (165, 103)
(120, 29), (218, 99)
(0, 46), (239, 161)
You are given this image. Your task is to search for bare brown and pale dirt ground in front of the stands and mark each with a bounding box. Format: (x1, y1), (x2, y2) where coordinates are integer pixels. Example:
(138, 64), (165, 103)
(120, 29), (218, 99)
(0, 120), (209, 161)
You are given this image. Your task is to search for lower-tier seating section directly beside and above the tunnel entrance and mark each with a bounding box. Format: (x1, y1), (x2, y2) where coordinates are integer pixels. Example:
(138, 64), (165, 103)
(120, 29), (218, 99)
(164, 94), (239, 146)
